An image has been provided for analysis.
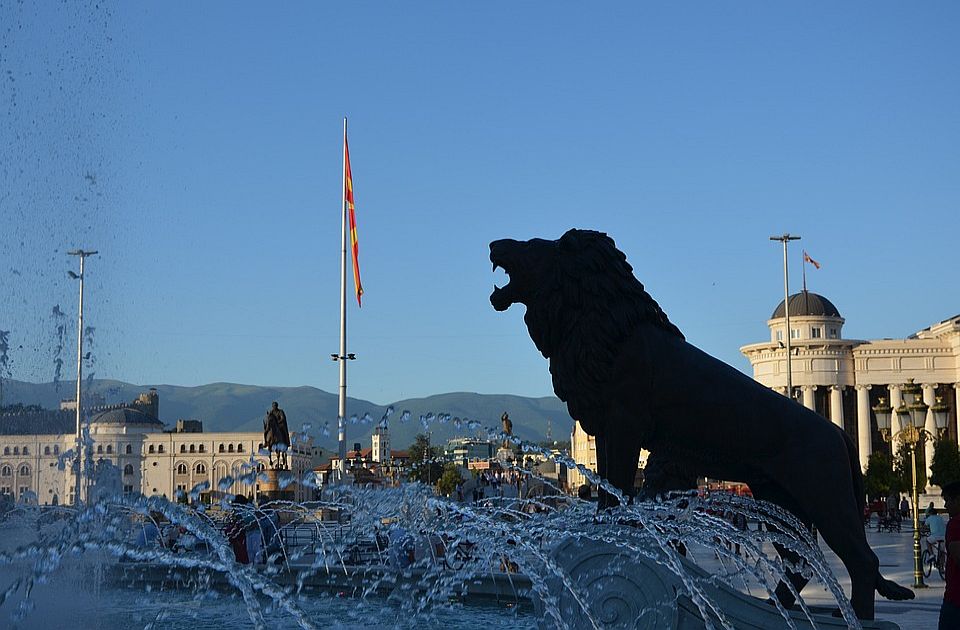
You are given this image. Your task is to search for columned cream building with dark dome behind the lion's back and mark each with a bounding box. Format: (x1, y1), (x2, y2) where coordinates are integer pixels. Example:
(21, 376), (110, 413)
(740, 291), (960, 486)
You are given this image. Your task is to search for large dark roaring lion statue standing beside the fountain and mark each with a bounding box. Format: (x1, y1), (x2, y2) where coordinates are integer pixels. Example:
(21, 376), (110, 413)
(490, 229), (914, 619)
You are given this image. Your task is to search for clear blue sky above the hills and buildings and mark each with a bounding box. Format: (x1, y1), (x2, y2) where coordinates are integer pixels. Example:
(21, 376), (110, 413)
(0, 2), (960, 403)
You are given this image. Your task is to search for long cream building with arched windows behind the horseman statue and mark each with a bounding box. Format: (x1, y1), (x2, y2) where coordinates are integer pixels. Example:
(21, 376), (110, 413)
(0, 390), (313, 505)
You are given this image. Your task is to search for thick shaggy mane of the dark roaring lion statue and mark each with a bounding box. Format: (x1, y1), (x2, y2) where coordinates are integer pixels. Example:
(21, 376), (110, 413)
(524, 230), (683, 435)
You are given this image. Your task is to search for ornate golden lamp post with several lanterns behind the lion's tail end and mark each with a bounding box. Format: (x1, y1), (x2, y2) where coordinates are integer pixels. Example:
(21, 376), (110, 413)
(873, 378), (949, 588)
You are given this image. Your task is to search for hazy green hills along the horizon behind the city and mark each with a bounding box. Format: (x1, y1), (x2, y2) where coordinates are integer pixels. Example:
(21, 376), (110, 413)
(3, 379), (573, 450)
